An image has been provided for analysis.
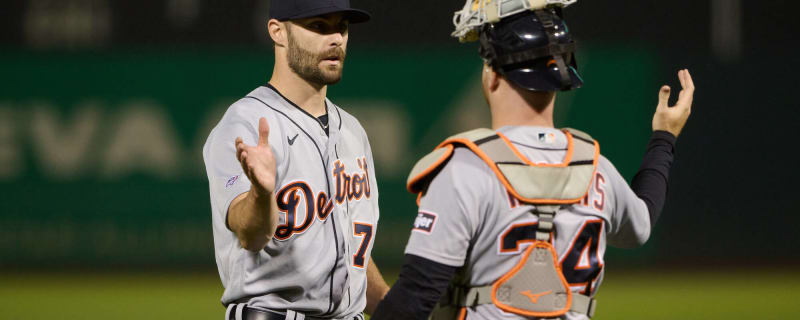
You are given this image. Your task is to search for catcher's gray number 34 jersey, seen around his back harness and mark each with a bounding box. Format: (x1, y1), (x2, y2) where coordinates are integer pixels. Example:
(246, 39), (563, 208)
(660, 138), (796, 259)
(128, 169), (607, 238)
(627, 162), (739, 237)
(406, 126), (650, 320)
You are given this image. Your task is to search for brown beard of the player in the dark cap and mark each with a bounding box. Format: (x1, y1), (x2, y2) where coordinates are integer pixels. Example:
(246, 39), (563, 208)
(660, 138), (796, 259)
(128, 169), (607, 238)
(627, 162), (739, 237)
(288, 32), (347, 86)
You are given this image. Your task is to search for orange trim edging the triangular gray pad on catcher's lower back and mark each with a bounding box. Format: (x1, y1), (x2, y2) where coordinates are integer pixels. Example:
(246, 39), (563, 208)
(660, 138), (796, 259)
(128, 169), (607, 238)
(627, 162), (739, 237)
(492, 241), (572, 318)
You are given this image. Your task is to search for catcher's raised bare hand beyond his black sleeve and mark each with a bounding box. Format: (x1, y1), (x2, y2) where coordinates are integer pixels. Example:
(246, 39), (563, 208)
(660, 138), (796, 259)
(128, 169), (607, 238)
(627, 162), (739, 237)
(653, 69), (694, 137)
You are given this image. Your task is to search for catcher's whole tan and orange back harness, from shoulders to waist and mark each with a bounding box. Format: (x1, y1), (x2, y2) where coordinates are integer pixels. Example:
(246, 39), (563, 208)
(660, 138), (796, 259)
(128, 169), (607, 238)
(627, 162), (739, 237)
(407, 129), (600, 319)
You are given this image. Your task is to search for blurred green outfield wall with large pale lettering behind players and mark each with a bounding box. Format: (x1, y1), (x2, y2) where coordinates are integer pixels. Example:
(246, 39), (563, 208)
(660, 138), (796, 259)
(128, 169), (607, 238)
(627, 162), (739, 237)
(0, 47), (658, 268)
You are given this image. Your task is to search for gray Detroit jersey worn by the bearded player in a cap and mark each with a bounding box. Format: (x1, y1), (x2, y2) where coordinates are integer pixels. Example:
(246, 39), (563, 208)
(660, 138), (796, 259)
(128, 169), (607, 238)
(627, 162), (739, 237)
(203, 86), (379, 318)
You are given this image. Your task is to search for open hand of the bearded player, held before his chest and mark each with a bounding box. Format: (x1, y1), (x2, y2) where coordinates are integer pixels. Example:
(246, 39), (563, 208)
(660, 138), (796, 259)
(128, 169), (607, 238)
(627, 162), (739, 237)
(236, 118), (275, 195)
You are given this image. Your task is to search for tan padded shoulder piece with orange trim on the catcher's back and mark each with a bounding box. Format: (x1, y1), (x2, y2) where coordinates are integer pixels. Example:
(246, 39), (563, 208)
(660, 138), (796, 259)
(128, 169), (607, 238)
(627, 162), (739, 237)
(407, 129), (600, 204)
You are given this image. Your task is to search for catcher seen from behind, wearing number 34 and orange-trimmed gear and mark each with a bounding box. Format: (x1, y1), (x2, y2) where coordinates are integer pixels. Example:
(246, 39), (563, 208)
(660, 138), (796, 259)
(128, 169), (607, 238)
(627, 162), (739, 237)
(373, 0), (694, 320)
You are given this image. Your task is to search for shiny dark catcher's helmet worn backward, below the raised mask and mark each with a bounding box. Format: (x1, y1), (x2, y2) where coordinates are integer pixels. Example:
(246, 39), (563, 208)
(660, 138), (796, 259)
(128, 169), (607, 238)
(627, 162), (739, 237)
(479, 8), (583, 91)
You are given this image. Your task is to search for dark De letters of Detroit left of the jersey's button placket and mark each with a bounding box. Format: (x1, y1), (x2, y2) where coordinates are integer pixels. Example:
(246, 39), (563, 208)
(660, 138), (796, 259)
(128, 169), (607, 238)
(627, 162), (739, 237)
(274, 181), (333, 240)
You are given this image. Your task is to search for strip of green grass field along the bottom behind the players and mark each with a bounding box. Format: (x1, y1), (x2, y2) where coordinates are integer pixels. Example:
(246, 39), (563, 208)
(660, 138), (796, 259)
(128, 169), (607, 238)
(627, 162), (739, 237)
(0, 270), (800, 320)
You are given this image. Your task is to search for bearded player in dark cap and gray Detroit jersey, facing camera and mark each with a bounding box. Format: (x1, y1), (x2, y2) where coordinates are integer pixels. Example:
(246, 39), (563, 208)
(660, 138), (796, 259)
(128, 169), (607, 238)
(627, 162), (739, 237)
(203, 0), (388, 320)
